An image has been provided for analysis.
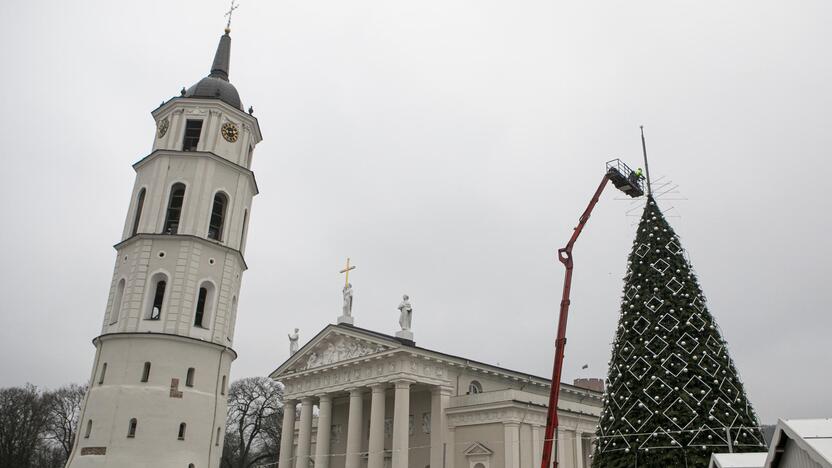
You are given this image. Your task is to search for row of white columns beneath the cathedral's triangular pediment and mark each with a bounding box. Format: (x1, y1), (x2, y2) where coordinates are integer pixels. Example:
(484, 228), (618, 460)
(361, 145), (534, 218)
(278, 380), (451, 468)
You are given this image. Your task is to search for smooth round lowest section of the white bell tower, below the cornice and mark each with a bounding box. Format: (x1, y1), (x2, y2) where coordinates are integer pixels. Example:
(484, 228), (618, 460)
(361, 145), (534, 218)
(67, 333), (236, 468)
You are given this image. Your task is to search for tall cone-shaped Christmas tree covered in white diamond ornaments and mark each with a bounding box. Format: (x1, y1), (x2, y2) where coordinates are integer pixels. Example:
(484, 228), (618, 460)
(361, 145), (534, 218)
(592, 196), (765, 468)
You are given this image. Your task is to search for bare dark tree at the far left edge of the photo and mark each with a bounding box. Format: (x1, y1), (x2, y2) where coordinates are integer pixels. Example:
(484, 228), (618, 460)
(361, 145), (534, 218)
(0, 384), (48, 468)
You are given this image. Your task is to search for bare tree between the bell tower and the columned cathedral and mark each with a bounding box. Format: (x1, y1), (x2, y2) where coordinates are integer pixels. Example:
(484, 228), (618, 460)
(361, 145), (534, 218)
(222, 377), (283, 468)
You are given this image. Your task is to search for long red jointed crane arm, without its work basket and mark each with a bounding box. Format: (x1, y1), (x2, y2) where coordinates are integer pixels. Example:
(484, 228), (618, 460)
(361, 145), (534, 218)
(540, 174), (610, 468)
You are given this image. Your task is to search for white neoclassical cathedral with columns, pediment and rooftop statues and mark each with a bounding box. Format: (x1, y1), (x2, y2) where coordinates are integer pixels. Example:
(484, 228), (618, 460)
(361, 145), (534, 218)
(271, 320), (602, 468)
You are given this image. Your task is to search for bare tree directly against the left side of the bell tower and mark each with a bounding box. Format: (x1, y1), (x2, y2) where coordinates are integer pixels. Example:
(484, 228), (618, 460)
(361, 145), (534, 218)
(43, 384), (87, 461)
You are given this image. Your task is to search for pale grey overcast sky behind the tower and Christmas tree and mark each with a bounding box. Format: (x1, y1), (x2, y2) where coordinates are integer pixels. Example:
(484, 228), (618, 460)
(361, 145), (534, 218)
(0, 0), (832, 423)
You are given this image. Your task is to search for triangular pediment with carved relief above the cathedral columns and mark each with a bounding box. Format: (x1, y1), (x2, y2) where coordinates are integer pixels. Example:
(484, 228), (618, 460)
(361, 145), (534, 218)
(273, 326), (395, 377)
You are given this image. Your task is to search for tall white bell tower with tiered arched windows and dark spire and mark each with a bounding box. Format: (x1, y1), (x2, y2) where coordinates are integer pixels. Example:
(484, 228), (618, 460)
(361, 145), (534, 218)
(67, 29), (262, 468)
